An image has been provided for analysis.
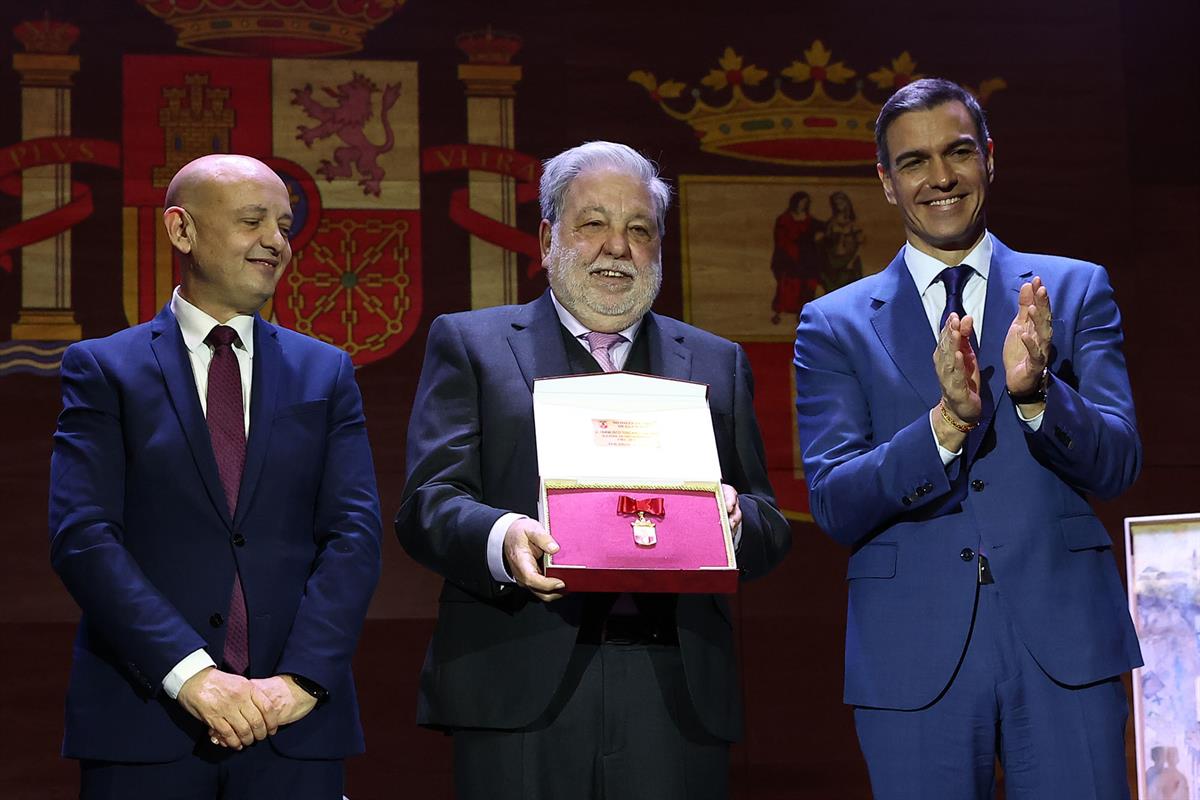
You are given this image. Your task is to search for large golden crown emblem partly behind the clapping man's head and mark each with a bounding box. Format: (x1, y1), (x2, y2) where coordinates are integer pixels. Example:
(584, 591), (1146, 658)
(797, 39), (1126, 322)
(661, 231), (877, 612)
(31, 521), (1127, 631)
(629, 40), (1006, 166)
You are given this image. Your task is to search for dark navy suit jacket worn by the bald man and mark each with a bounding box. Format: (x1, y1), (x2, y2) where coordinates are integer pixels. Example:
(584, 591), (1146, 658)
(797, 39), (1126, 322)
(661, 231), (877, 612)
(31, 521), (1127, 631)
(50, 307), (380, 762)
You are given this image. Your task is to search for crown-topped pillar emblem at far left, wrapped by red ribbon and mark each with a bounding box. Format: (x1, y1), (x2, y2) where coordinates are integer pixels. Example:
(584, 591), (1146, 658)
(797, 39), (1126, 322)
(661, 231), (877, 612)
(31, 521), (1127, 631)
(12, 18), (79, 341)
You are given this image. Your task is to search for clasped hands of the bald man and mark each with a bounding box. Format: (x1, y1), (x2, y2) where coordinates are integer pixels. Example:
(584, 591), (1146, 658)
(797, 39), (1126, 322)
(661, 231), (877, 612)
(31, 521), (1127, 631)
(179, 667), (317, 750)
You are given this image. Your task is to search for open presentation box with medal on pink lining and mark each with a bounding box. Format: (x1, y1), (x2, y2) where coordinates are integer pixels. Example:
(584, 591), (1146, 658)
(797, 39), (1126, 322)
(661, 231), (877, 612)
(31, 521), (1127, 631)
(533, 372), (738, 594)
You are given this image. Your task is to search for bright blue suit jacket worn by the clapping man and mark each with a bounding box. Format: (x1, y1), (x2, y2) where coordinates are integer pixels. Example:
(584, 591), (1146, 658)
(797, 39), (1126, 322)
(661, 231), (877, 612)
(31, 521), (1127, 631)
(796, 241), (1141, 709)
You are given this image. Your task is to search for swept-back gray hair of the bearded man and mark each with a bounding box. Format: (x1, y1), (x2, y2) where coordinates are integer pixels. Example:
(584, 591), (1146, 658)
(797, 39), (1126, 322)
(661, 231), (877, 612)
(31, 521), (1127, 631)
(539, 142), (671, 236)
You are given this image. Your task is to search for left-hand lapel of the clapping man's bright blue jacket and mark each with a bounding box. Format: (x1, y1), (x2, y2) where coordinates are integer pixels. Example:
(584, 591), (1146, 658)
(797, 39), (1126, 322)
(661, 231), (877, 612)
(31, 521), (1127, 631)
(871, 247), (942, 408)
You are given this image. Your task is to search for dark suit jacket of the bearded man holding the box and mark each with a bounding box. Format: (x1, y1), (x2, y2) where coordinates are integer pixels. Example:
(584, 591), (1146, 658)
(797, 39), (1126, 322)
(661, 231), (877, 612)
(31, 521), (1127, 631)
(396, 291), (791, 740)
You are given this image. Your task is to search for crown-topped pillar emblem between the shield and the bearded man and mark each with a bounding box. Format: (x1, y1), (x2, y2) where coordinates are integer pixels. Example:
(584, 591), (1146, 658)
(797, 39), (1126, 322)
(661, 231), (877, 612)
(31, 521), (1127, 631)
(456, 28), (521, 308)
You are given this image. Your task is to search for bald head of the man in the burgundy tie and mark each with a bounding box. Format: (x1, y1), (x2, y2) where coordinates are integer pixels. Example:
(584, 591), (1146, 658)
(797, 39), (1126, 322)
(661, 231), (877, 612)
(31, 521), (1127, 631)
(163, 154), (292, 323)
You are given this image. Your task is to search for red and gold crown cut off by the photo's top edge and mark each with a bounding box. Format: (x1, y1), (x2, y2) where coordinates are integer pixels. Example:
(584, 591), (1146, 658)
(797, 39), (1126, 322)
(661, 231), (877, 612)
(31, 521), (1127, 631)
(138, 0), (404, 58)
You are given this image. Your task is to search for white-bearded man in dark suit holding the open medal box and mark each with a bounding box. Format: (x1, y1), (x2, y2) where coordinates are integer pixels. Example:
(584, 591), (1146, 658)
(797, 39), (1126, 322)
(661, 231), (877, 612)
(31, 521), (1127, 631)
(396, 142), (791, 800)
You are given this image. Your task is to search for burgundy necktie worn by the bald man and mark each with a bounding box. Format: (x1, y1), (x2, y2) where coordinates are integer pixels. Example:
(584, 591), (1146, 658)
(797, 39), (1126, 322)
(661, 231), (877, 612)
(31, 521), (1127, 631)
(204, 325), (250, 674)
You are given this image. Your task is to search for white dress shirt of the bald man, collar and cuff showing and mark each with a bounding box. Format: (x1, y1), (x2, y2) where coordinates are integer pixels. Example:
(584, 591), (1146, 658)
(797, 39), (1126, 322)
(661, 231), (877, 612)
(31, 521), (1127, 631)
(162, 287), (254, 699)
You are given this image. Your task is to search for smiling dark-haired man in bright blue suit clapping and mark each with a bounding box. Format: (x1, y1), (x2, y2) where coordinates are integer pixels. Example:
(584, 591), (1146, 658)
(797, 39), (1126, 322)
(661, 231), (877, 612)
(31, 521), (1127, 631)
(796, 79), (1141, 800)
